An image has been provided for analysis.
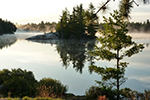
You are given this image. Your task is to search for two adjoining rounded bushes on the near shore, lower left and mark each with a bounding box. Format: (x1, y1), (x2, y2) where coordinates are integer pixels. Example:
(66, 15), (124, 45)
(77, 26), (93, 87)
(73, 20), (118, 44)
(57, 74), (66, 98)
(0, 68), (67, 98)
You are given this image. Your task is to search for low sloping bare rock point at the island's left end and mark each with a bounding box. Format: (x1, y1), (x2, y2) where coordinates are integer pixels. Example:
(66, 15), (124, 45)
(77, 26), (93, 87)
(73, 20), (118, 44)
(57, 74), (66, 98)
(27, 32), (59, 40)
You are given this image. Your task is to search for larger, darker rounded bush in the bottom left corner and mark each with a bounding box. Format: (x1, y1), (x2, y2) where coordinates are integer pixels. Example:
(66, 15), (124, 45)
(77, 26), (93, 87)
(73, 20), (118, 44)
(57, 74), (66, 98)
(0, 68), (36, 97)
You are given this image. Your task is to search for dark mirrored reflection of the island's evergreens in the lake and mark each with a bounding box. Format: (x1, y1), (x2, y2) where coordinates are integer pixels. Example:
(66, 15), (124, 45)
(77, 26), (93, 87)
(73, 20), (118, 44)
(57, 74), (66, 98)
(27, 40), (96, 73)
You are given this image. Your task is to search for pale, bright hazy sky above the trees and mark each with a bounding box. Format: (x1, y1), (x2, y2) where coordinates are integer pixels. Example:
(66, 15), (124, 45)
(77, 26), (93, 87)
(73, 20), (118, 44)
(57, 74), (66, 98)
(0, 0), (150, 24)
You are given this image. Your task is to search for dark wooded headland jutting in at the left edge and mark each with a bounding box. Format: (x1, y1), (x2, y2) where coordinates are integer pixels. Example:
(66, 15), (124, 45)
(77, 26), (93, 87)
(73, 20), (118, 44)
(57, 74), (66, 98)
(0, 18), (17, 35)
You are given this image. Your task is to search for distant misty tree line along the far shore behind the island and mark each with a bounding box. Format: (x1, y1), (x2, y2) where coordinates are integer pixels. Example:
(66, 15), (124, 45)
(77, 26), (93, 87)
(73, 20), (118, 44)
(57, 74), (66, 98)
(17, 19), (150, 37)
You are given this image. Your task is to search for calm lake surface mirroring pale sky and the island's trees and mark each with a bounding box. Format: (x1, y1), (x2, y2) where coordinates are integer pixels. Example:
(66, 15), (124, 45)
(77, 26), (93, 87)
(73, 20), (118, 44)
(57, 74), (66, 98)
(0, 32), (150, 95)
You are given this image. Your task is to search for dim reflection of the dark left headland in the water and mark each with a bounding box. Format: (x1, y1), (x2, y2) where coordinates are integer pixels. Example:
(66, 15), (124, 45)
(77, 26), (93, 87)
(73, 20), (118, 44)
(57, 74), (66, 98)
(0, 35), (17, 49)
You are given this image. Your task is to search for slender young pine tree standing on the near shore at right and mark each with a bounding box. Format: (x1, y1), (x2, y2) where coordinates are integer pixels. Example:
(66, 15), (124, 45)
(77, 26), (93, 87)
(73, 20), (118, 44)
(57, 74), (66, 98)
(89, 11), (144, 100)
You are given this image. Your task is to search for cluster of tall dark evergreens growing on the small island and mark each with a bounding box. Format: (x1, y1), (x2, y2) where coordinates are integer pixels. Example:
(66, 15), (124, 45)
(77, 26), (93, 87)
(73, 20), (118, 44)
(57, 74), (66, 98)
(56, 4), (98, 39)
